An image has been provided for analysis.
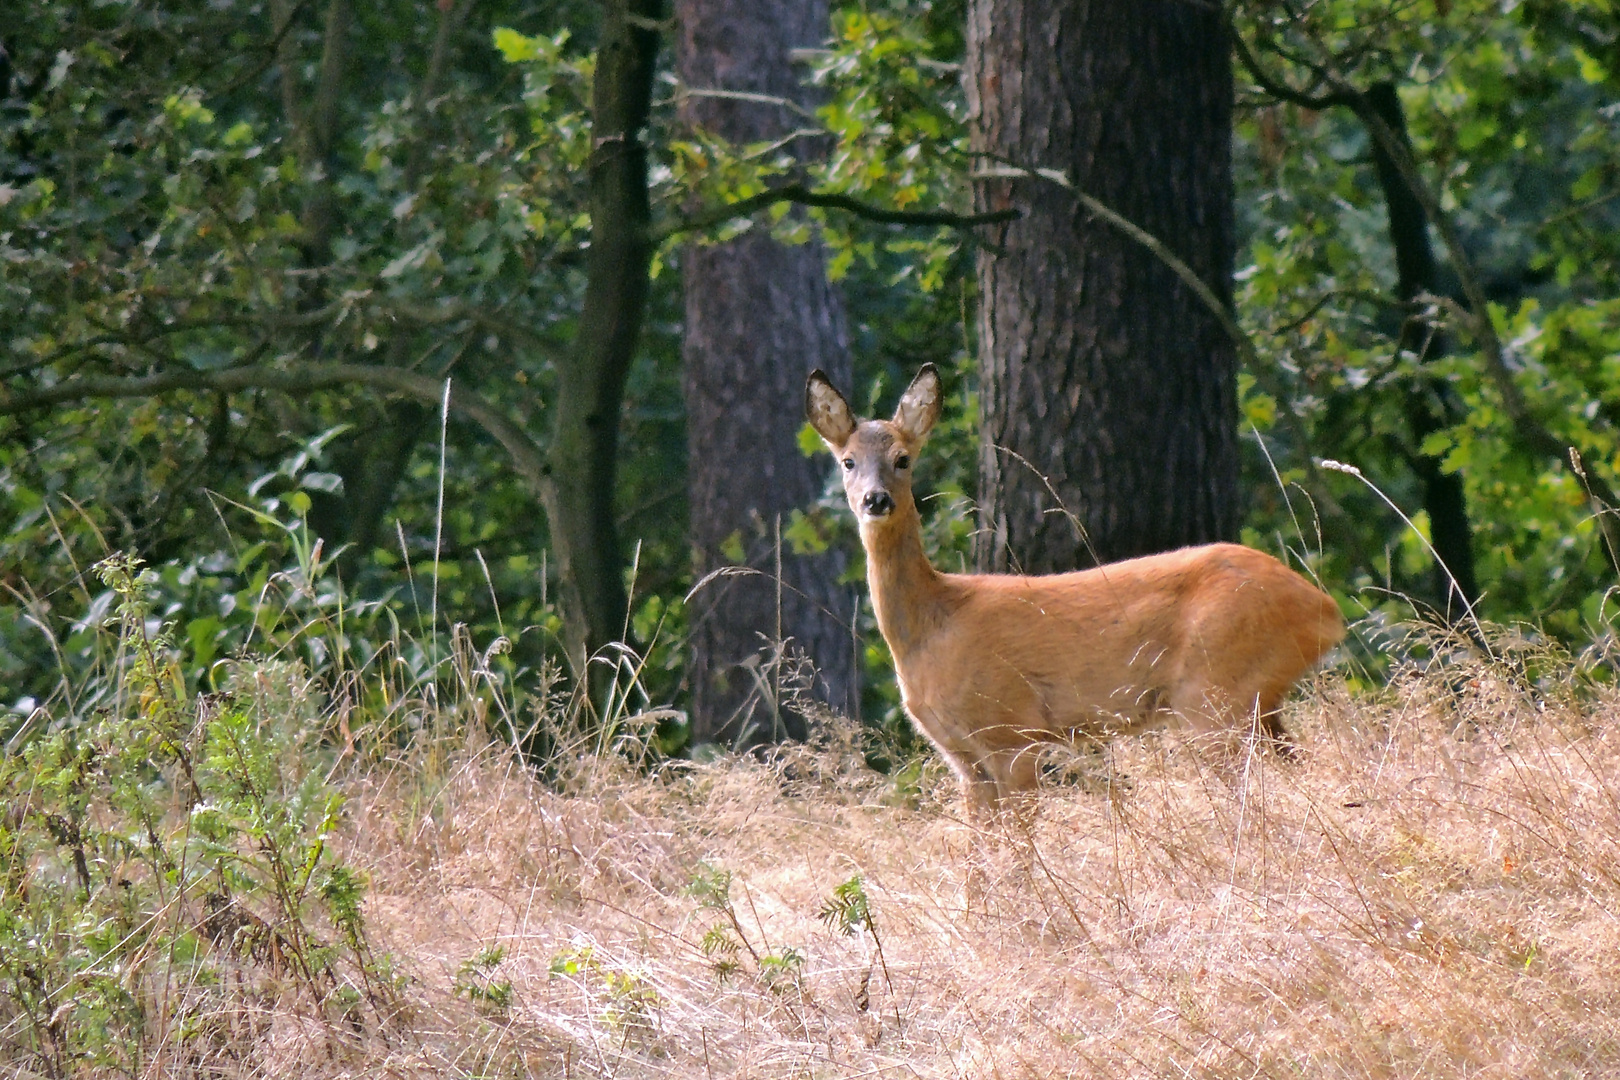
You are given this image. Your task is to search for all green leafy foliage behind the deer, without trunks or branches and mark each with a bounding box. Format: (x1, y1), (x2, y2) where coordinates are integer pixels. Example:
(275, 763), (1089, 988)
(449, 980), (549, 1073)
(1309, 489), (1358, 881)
(9, 0), (1620, 748)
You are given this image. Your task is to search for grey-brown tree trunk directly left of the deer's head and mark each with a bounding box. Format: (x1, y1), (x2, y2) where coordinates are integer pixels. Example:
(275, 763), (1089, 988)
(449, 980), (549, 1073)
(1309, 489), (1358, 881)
(676, 0), (855, 743)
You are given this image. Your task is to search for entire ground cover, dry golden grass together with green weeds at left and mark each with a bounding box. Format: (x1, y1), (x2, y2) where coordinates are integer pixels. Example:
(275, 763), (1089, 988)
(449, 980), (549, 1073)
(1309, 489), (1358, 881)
(0, 562), (1620, 1078)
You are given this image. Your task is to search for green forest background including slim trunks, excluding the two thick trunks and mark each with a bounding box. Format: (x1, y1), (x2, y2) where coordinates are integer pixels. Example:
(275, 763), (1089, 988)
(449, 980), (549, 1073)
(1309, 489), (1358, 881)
(0, 0), (1620, 750)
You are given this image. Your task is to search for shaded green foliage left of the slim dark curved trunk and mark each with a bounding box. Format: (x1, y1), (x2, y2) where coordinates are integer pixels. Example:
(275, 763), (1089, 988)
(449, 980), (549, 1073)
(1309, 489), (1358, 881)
(0, 0), (687, 718)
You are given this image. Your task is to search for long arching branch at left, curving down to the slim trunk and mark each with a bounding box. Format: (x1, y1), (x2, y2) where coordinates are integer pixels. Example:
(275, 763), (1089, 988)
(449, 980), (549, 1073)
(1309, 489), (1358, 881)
(0, 364), (551, 500)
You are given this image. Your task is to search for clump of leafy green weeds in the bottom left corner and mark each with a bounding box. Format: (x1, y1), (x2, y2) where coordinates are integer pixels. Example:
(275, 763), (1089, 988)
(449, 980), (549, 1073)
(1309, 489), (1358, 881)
(0, 557), (395, 1077)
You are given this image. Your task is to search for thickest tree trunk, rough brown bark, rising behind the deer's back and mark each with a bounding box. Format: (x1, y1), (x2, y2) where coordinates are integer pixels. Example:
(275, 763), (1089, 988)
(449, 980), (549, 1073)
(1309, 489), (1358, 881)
(967, 0), (1239, 573)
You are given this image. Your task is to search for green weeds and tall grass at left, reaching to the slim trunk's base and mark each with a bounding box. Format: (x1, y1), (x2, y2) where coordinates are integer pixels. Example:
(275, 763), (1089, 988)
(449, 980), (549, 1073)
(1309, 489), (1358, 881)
(0, 507), (663, 1077)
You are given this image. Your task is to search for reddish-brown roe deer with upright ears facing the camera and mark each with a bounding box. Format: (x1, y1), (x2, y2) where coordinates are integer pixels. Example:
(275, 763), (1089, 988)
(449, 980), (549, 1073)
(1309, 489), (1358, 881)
(805, 364), (1345, 810)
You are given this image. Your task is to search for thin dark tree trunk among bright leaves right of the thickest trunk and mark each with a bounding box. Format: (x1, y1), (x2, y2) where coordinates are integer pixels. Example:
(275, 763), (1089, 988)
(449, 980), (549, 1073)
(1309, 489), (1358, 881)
(1366, 83), (1479, 620)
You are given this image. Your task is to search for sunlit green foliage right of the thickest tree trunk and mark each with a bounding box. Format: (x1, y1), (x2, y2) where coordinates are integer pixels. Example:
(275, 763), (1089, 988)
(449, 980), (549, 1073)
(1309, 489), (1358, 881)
(1238, 3), (1620, 641)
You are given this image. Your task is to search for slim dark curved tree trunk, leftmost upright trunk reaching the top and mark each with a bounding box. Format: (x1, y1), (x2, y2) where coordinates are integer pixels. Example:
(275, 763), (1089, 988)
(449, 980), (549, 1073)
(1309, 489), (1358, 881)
(546, 0), (661, 674)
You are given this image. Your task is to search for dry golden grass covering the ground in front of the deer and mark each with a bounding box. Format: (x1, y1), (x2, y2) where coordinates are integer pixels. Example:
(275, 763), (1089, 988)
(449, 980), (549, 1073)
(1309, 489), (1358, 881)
(303, 669), (1620, 1078)
